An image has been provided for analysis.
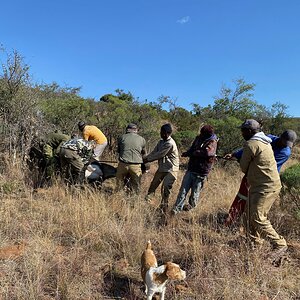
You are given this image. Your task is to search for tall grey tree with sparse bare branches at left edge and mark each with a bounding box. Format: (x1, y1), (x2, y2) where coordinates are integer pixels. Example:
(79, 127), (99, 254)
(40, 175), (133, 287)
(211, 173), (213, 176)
(0, 49), (38, 158)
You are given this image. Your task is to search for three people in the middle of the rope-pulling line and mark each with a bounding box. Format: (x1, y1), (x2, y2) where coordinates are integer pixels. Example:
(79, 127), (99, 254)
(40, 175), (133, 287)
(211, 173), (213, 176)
(116, 123), (218, 218)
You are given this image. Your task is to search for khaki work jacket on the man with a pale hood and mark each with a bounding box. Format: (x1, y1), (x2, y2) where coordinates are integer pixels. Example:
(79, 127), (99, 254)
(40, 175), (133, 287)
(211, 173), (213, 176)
(240, 140), (281, 192)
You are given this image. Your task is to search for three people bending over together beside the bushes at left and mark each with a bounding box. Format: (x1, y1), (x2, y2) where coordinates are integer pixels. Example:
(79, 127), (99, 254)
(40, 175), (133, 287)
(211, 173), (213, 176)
(34, 121), (107, 185)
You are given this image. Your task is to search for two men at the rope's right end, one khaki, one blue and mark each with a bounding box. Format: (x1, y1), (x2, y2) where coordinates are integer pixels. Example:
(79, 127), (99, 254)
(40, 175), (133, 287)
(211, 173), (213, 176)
(225, 119), (297, 261)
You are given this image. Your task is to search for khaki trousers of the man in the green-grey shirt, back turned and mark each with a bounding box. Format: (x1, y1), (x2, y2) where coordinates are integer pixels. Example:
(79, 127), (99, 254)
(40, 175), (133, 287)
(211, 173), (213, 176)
(116, 161), (142, 193)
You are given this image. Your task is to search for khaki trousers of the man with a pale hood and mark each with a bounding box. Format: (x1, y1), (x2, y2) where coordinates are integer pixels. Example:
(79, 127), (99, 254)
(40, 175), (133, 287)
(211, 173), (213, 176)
(246, 189), (286, 249)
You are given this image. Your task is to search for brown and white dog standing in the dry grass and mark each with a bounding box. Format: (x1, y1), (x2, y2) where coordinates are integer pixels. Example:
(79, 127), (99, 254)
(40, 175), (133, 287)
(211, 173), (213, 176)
(141, 241), (186, 300)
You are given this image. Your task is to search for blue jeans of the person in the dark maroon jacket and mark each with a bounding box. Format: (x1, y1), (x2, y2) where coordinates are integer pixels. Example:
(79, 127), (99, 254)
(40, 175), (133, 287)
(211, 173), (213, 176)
(173, 171), (206, 212)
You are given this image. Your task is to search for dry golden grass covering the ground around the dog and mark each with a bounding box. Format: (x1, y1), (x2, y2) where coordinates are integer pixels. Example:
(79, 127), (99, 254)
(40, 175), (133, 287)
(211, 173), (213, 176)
(0, 158), (300, 300)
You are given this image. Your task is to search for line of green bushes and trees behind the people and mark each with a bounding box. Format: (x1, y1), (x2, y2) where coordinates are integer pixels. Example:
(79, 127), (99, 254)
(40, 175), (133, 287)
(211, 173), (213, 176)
(0, 50), (300, 162)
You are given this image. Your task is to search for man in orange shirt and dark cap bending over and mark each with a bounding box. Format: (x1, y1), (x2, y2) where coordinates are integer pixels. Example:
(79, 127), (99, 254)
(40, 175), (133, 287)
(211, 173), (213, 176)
(78, 121), (107, 161)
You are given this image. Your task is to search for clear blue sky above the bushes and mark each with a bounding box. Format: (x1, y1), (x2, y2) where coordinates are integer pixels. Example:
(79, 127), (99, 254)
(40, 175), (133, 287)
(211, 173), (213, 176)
(0, 0), (300, 117)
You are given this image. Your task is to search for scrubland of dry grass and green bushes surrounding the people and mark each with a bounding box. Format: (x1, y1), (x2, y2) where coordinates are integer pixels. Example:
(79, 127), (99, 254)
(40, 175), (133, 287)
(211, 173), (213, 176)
(0, 51), (300, 300)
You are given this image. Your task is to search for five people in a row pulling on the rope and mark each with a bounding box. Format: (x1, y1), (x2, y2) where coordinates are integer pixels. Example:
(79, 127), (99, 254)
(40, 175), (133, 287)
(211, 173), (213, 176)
(117, 119), (297, 258)
